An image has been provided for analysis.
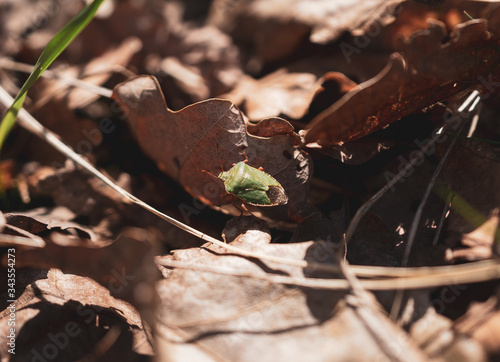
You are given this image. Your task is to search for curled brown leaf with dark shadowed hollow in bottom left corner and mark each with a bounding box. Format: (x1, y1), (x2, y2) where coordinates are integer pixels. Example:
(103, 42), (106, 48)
(0, 268), (153, 361)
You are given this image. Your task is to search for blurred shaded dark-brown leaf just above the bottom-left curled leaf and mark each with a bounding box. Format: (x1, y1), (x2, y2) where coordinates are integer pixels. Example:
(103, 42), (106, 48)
(3, 228), (156, 326)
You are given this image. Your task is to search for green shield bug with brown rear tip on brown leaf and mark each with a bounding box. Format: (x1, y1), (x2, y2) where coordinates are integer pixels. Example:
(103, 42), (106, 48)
(218, 162), (288, 206)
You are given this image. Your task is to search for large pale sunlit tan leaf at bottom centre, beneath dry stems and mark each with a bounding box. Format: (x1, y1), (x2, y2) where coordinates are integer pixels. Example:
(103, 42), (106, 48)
(157, 219), (423, 361)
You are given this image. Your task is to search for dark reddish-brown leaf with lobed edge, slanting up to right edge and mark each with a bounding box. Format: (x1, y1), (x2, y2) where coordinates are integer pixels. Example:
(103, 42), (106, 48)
(305, 20), (500, 145)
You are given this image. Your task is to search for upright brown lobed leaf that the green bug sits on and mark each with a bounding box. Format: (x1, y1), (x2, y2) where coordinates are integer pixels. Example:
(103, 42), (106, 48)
(113, 76), (311, 220)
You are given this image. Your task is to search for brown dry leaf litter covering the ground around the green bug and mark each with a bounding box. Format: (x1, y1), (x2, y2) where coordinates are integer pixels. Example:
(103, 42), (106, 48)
(0, 0), (500, 361)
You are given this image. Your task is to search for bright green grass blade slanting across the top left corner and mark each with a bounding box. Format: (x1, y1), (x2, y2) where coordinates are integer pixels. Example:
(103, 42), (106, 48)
(0, 0), (104, 151)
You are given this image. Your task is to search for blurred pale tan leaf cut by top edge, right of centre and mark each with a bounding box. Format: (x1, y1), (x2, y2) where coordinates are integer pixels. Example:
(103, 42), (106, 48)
(209, 0), (401, 48)
